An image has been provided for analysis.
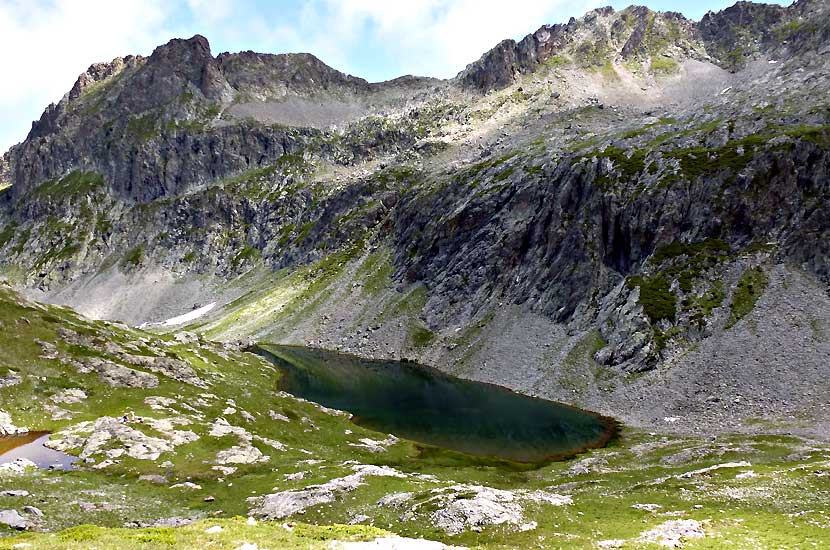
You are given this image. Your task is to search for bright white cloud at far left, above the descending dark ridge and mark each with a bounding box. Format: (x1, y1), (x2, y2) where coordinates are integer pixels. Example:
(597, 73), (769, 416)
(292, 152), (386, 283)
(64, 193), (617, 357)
(0, 0), (169, 151)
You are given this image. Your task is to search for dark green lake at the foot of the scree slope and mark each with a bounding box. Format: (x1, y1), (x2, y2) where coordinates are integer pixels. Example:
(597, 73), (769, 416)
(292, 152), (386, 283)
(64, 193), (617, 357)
(257, 345), (615, 462)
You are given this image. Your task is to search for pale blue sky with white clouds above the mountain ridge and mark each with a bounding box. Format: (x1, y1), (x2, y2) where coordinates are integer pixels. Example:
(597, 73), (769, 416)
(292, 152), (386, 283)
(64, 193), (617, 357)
(0, 0), (790, 153)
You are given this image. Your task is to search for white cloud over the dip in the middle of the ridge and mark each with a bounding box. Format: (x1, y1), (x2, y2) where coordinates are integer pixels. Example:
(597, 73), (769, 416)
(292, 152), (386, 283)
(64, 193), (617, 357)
(259, 0), (601, 81)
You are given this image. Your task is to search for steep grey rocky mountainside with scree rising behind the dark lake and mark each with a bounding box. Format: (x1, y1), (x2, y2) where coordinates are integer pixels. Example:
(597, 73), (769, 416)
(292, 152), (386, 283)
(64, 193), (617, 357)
(0, 0), (830, 433)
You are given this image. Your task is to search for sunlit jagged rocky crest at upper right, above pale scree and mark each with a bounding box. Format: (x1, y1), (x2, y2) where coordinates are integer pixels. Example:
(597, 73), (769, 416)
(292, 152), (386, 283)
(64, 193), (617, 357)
(456, 0), (827, 92)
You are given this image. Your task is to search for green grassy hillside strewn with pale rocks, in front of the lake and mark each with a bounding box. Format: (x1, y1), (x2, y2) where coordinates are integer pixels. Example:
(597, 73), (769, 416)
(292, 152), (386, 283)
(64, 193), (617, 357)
(0, 287), (830, 548)
